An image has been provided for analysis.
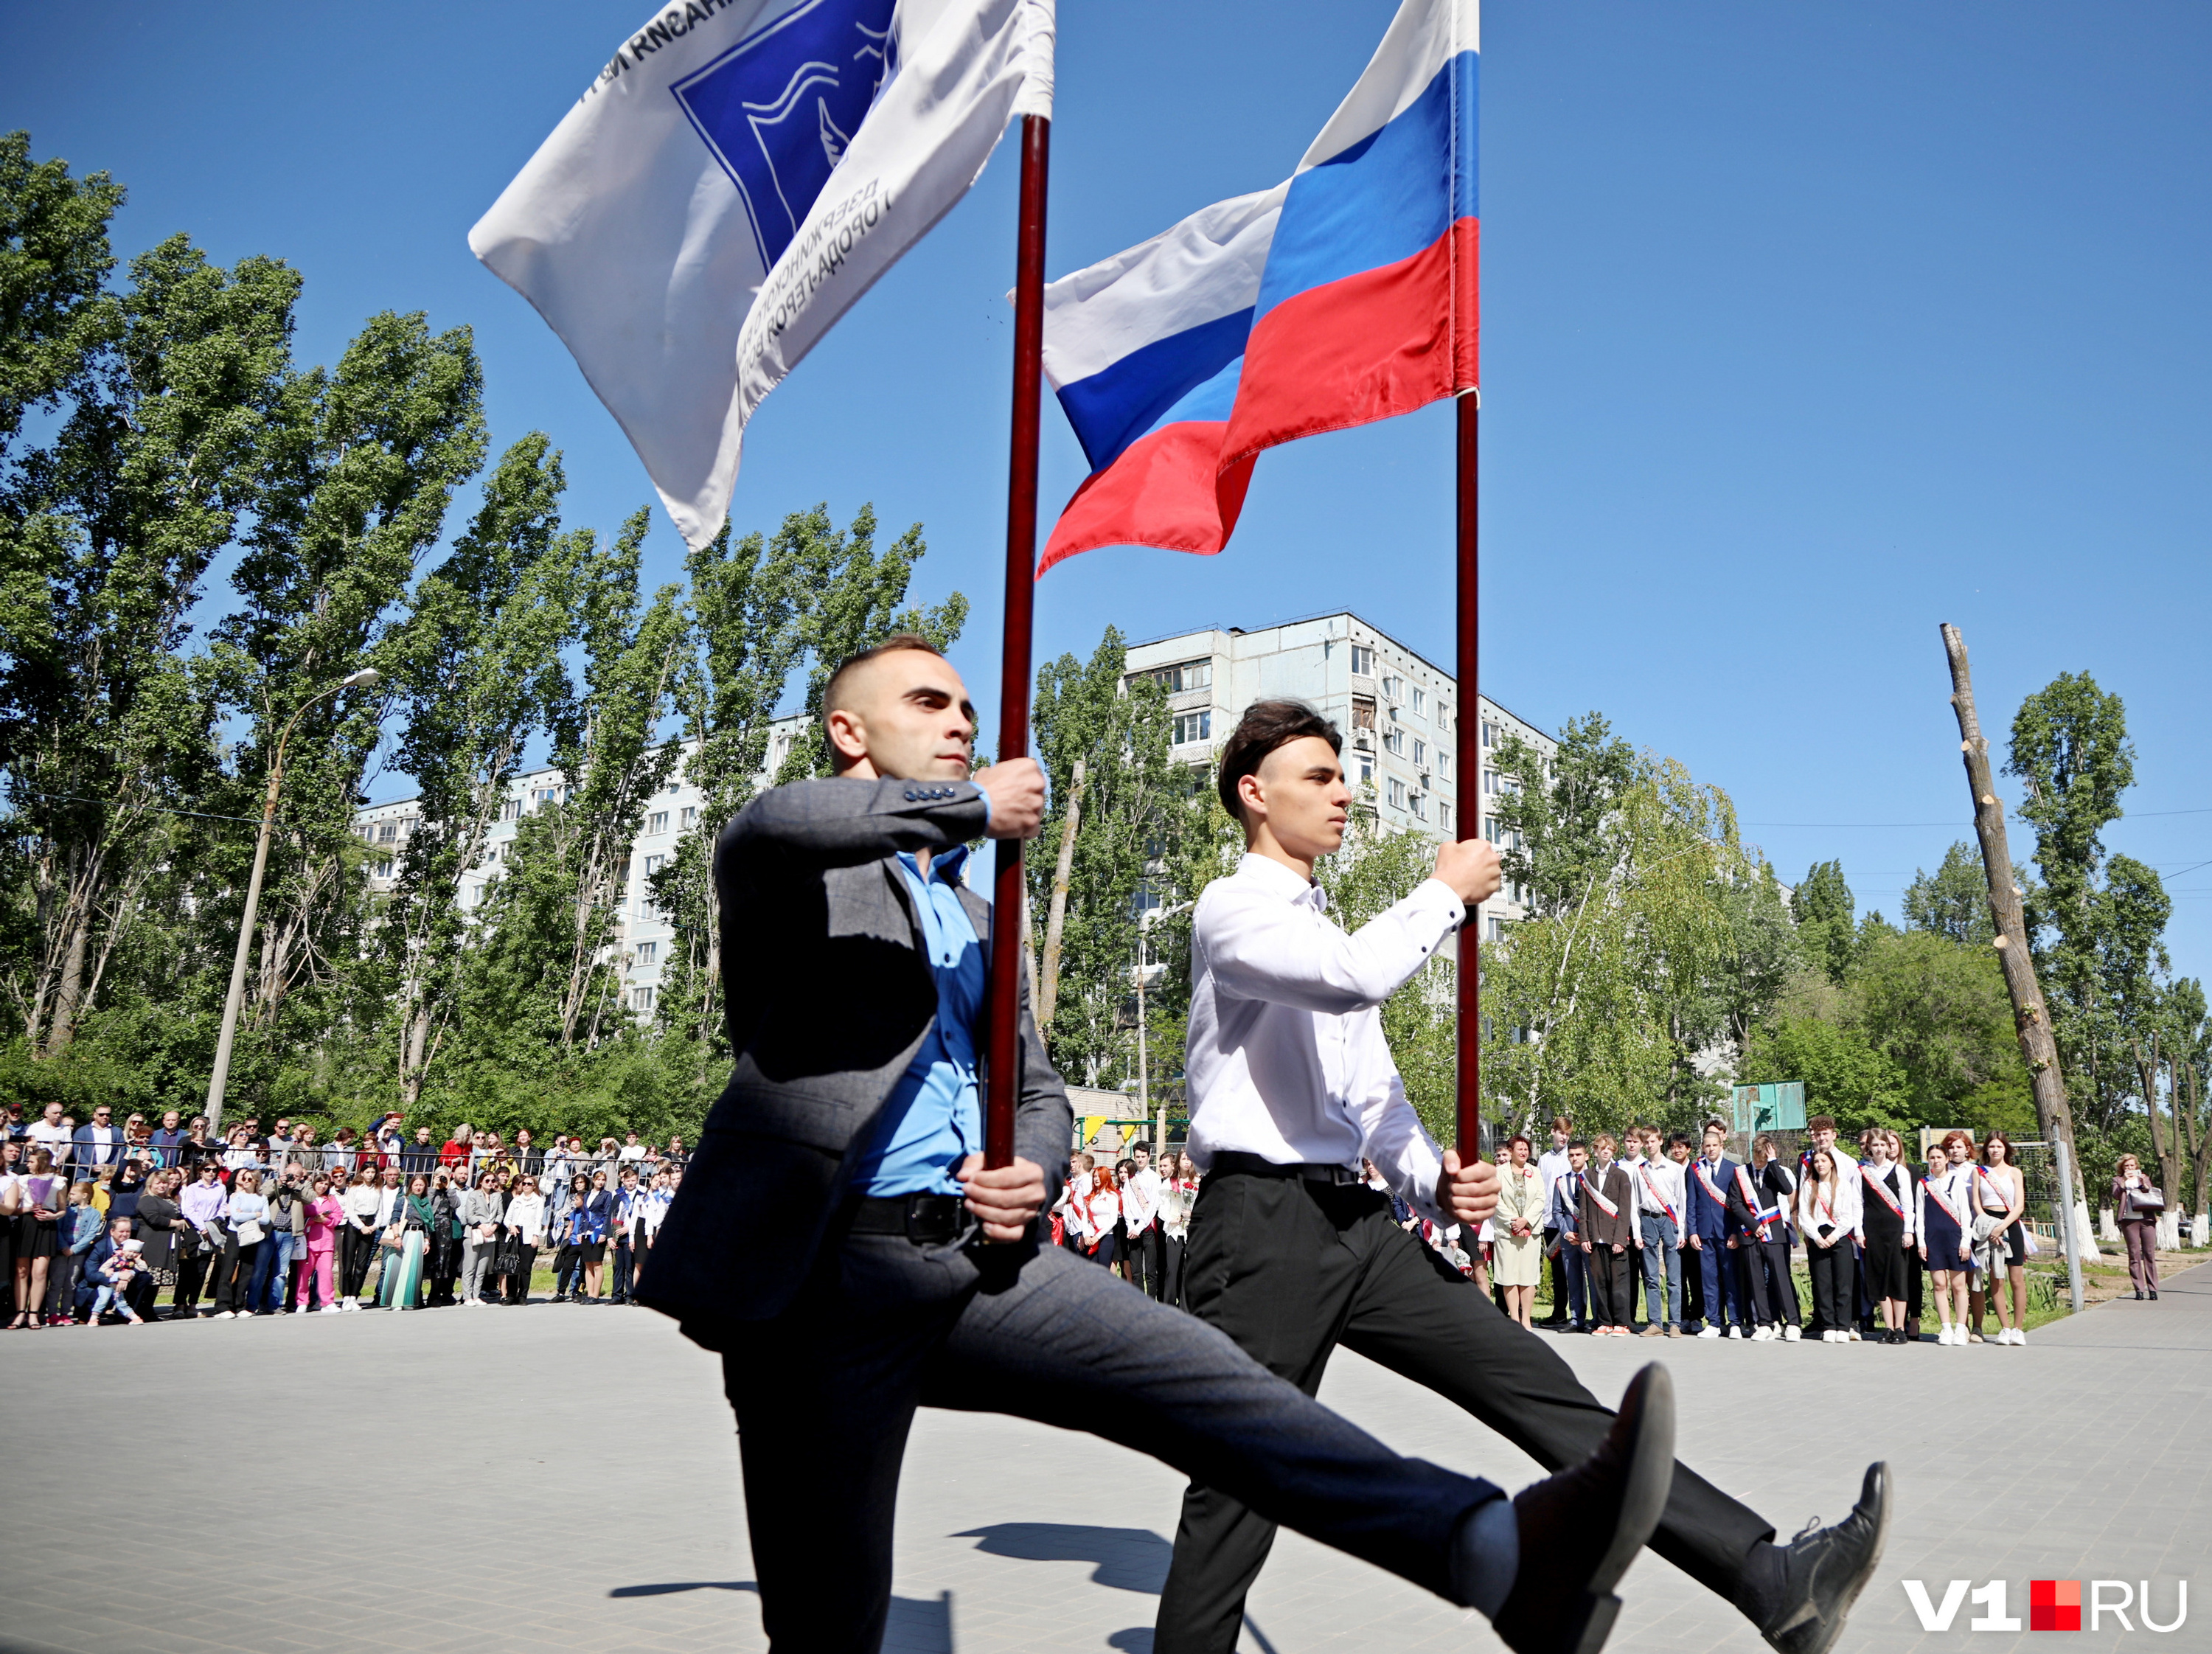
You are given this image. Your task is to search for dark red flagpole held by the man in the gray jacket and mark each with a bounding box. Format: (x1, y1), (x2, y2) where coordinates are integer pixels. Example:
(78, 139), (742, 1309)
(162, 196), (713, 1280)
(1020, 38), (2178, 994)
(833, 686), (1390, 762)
(982, 115), (1053, 1165)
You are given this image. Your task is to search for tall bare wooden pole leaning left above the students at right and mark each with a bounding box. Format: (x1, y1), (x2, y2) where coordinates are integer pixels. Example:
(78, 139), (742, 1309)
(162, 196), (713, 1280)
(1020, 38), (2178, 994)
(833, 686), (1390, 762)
(1942, 624), (2088, 1313)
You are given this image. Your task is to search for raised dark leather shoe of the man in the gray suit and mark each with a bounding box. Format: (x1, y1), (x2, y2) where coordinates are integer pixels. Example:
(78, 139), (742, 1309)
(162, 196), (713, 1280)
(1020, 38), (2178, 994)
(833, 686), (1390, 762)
(1491, 1362), (1674, 1654)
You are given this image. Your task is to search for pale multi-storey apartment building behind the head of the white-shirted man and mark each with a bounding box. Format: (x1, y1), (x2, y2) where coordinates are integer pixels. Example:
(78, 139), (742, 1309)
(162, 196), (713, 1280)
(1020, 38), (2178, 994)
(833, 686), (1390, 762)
(1128, 611), (1557, 939)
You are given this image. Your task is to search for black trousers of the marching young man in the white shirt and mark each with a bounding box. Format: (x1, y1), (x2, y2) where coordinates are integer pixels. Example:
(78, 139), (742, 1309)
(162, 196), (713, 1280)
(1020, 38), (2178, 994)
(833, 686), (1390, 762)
(1152, 1172), (1774, 1654)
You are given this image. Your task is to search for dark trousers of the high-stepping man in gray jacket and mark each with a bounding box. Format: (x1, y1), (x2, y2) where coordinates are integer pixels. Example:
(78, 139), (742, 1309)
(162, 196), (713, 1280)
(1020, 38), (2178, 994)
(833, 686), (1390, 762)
(723, 1236), (1498, 1654)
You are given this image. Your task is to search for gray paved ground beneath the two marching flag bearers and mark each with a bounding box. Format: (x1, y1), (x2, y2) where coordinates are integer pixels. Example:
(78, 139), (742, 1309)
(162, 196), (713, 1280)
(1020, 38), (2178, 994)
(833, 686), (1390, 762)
(0, 1267), (2212, 1654)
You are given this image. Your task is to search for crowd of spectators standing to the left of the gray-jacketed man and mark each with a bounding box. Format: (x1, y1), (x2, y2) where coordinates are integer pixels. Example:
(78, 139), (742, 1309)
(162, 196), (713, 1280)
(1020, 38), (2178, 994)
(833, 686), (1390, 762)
(0, 1103), (688, 1331)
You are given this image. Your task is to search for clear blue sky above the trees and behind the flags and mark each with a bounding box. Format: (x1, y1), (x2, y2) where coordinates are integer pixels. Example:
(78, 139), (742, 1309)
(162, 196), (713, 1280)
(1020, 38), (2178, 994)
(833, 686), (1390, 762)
(0, 0), (2212, 973)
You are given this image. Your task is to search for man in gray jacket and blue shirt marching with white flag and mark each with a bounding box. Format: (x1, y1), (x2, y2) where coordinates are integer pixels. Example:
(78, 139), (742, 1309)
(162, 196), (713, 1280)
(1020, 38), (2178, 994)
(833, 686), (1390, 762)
(639, 637), (1674, 1654)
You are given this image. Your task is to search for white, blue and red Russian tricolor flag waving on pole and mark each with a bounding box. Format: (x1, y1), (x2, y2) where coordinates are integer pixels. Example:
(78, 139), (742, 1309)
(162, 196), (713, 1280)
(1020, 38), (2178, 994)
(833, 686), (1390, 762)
(1037, 0), (1480, 575)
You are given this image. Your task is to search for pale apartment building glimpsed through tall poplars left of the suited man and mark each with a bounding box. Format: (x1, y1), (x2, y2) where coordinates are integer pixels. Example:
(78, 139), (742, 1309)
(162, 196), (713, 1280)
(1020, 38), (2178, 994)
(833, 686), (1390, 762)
(354, 715), (805, 1017)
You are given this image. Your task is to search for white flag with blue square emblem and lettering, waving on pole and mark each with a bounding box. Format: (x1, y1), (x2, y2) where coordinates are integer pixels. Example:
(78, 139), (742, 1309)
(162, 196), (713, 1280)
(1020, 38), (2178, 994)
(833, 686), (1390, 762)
(469, 0), (1053, 546)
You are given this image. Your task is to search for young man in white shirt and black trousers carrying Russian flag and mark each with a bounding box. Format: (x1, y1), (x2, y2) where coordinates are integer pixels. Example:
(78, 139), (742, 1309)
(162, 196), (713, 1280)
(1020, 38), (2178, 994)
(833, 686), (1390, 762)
(1155, 701), (1887, 1654)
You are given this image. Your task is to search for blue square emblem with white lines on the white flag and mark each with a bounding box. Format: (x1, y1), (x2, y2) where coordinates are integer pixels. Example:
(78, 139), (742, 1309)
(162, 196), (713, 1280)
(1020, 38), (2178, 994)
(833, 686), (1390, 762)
(668, 0), (898, 270)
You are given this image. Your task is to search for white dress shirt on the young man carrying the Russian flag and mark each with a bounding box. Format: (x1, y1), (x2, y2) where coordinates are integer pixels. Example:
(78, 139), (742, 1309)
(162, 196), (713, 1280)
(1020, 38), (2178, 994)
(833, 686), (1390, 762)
(1183, 853), (1467, 1223)
